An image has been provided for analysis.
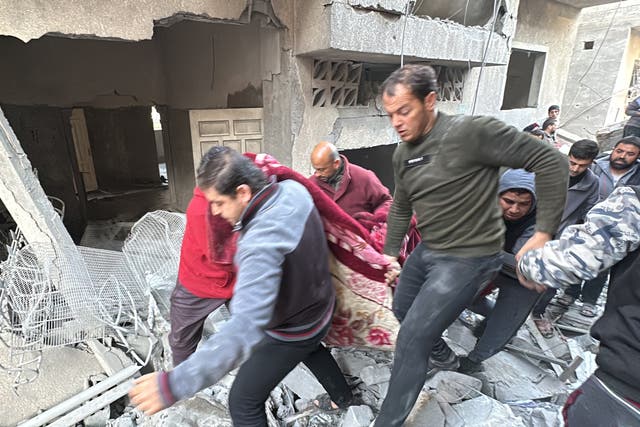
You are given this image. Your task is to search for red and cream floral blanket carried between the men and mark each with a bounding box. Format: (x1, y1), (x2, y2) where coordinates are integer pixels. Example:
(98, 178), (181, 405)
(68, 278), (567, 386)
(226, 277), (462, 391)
(245, 153), (402, 349)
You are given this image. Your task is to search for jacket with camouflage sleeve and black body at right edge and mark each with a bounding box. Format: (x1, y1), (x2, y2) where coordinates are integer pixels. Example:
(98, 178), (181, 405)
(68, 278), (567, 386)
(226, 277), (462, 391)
(519, 187), (640, 405)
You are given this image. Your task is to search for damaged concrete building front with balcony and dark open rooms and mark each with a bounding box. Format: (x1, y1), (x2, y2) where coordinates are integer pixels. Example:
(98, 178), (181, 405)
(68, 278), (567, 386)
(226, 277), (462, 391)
(0, 0), (620, 237)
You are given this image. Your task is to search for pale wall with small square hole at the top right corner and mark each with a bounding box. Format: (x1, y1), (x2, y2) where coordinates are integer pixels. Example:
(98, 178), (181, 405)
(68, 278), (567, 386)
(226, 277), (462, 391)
(562, 0), (640, 138)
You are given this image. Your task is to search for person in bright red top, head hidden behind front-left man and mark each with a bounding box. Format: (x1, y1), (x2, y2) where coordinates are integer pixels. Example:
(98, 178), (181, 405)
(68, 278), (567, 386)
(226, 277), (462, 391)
(169, 187), (236, 366)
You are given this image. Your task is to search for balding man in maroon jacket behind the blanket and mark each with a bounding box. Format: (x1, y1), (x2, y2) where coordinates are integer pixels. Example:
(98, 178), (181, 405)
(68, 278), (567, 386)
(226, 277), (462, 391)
(309, 141), (392, 222)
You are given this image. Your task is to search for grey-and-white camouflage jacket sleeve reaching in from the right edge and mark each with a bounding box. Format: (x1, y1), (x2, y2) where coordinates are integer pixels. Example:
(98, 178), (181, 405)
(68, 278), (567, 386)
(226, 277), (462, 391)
(518, 187), (640, 288)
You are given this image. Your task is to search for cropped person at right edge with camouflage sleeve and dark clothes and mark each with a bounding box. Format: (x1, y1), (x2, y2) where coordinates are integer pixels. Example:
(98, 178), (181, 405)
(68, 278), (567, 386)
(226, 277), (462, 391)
(518, 186), (640, 427)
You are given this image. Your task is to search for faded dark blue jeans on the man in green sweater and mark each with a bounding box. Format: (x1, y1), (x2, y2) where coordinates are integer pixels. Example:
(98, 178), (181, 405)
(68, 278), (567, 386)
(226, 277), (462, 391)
(375, 244), (502, 427)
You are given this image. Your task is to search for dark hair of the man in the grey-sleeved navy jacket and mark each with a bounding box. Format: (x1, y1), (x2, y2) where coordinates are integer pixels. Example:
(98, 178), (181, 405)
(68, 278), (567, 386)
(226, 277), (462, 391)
(197, 147), (267, 197)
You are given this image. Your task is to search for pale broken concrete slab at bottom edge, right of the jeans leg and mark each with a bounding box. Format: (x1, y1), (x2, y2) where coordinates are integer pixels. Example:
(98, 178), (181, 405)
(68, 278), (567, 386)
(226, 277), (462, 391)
(453, 396), (525, 427)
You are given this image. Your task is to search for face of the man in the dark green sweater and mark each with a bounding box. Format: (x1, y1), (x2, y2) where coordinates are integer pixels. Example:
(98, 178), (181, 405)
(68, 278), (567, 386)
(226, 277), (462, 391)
(382, 84), (436, 142)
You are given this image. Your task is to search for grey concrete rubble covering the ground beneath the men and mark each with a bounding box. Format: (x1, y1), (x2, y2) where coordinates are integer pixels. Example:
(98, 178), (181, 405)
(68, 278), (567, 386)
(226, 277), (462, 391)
(0, 300), (595, 427)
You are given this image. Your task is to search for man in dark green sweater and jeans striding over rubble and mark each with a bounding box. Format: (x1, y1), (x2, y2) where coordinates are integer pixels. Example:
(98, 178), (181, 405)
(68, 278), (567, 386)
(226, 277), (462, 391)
(376, 64), (567, 427)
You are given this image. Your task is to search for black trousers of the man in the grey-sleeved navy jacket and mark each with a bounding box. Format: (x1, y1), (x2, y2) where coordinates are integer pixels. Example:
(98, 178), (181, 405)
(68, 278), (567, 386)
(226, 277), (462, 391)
(229, 325), (352, 427)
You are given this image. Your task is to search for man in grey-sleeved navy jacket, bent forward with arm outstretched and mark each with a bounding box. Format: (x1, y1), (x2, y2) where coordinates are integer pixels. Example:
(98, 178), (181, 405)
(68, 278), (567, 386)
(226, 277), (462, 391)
(129, 147), (352, 426)
